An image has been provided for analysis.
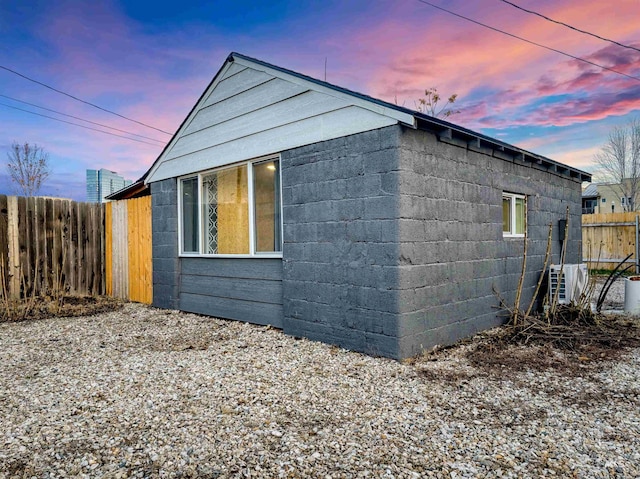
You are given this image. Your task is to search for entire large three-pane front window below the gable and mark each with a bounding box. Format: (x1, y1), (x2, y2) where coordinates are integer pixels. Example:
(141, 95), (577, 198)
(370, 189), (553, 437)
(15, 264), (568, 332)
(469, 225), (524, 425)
(180, 159), (282, 255)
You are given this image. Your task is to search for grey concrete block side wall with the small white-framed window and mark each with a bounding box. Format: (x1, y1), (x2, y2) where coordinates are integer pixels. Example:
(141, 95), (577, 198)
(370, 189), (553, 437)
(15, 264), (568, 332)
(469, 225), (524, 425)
(398, 125), (581, 357)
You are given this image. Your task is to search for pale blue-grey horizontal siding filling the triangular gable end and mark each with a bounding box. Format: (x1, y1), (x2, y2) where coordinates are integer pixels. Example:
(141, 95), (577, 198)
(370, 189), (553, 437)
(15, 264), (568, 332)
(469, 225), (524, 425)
(145, 58), (415, 183)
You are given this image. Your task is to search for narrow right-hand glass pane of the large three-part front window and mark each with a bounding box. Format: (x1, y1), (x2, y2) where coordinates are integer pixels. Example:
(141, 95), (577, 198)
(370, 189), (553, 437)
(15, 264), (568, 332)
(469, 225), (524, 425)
(253, 160), (282, 253)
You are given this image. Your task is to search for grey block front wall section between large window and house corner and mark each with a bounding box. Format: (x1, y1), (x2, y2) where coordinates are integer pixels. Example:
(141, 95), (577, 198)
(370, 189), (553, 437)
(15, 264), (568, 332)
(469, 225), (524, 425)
(281, 127), (401, 357)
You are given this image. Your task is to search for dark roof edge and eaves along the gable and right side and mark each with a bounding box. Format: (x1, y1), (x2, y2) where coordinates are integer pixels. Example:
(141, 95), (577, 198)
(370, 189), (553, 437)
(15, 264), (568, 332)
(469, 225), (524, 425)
(142, 52), (591, 184)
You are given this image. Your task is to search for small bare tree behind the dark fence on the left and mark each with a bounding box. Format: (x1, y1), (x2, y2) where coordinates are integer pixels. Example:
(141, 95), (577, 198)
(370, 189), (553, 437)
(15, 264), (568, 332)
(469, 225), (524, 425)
(7, 142), (51, 196)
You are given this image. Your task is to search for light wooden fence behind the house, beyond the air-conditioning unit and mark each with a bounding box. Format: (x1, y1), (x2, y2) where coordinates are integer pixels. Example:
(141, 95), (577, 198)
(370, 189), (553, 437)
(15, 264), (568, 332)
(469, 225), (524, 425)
(582, 212), (640, 269)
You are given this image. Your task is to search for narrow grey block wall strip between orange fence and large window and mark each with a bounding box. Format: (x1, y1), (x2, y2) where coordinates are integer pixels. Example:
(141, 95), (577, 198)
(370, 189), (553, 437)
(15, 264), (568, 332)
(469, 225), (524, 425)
(150, 178), (180, 309)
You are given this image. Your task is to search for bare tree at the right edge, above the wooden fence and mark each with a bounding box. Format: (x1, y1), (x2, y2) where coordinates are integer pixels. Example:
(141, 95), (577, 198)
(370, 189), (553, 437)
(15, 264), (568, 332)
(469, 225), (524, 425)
(594, 119), (640, 211)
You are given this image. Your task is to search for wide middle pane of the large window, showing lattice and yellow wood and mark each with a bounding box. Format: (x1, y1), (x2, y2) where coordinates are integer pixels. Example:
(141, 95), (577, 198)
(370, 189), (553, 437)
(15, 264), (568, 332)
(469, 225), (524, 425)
(202, 165), (249, 254)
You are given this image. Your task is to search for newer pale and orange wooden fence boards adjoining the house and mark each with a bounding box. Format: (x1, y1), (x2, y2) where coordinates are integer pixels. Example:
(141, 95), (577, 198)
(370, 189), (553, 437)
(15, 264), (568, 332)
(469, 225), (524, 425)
(105, 196), (153, 304)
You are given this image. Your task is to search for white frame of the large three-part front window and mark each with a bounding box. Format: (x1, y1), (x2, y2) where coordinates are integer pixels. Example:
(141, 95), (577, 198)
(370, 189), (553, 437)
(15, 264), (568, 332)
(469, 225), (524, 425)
(177, 154), (284, 258)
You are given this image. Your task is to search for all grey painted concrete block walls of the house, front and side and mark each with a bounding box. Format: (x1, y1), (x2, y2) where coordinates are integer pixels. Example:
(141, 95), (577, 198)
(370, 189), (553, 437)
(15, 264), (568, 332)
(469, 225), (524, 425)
(151, 126), (581, 358)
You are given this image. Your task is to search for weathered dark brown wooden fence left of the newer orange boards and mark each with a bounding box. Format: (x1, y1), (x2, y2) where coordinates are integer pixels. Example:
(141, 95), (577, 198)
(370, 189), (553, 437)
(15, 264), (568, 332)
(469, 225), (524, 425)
(0, 195), (105, 298)
